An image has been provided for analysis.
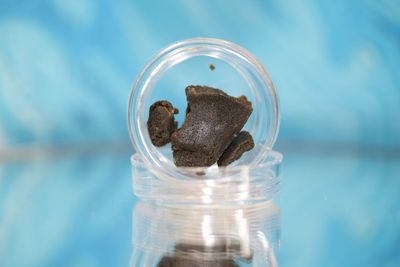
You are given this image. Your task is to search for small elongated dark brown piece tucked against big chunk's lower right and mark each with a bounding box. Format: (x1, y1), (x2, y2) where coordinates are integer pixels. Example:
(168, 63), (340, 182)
(218, 131), (254, 166)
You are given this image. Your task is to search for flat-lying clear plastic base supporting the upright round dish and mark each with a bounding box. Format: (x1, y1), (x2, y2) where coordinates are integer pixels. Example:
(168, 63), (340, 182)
(131, 145), (282, 205)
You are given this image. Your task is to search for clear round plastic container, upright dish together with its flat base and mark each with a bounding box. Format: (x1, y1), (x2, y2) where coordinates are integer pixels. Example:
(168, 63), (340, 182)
(128, 38), (282, 205)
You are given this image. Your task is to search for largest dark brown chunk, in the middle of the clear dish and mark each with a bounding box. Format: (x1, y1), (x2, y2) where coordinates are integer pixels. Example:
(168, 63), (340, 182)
(171, 86), (253, 167)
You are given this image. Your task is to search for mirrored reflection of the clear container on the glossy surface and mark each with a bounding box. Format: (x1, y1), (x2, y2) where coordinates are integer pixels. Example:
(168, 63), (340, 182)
(130, 201), (280, 267)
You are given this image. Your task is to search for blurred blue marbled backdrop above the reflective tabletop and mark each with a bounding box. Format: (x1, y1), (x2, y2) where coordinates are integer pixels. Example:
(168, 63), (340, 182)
(0, 0), (400, 147)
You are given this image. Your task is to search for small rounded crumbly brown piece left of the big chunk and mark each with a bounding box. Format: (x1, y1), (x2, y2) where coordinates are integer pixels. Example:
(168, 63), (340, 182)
(147, 100), (178, 146)
